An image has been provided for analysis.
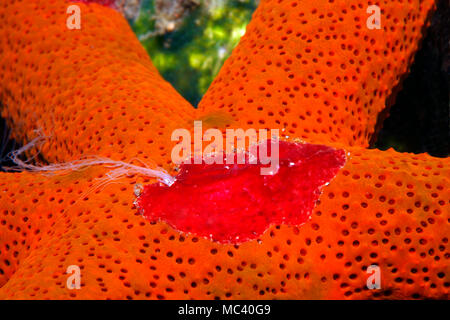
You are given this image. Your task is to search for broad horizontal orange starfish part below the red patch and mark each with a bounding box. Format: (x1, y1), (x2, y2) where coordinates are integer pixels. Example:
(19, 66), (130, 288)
(0, 149), (450, 299)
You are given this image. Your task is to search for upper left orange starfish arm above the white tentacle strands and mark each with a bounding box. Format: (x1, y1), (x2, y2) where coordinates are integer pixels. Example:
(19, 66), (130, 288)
(0, 0), (194, 166)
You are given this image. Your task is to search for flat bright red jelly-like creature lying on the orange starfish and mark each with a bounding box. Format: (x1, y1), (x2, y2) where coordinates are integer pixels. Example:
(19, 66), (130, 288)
(136, 141), (345, 244)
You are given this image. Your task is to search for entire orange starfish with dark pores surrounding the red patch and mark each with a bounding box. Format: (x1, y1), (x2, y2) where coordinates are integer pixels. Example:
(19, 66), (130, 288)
(0, 0), (450, 299)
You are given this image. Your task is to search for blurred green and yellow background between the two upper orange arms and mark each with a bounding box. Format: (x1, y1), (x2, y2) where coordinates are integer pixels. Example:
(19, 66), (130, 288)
(132, 0), (256, 106)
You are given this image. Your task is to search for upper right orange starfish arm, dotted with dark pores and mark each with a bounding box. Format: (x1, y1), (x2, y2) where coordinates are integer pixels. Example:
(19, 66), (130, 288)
(199, 0), (434, 147)
